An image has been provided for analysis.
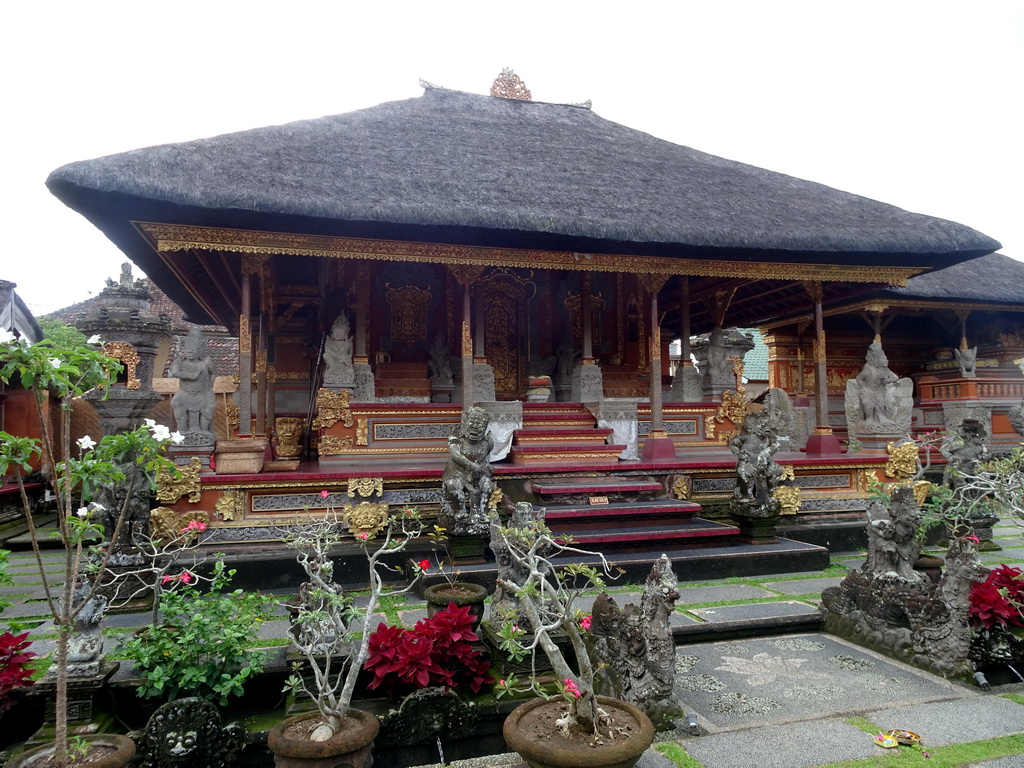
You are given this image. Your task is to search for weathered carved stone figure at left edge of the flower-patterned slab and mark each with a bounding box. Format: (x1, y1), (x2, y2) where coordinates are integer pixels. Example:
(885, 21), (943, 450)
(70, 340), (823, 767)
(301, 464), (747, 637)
(588, 555), (682, 730)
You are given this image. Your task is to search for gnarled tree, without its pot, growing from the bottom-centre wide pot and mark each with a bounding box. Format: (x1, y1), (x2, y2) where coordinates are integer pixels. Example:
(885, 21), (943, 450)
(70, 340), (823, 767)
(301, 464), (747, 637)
(492, 505), (612, 734)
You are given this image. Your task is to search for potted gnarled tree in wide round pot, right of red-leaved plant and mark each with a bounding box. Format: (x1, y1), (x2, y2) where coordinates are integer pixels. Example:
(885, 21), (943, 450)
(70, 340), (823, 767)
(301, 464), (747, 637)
(493, 515), (654, 768)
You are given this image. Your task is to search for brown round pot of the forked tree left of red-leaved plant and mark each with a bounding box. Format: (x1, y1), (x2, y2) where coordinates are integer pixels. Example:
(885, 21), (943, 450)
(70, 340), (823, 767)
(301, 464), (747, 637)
(266, 710), (381, 768)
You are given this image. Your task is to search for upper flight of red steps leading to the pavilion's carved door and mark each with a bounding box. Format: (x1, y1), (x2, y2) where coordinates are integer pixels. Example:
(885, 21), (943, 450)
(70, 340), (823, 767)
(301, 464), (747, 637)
(510, 402), (626, 465)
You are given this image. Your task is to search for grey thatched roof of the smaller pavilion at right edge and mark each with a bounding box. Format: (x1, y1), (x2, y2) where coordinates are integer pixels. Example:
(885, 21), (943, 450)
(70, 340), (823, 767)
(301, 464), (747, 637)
(884, 253), (1024, 305)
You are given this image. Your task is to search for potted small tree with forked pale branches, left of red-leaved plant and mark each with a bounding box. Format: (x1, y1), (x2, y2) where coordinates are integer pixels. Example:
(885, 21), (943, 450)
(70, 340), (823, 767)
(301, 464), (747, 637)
(267, 501), (423, 768)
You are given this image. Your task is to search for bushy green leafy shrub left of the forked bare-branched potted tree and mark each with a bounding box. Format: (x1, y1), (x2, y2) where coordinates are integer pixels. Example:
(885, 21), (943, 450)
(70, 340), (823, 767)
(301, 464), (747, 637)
(123, 560), (271, 707)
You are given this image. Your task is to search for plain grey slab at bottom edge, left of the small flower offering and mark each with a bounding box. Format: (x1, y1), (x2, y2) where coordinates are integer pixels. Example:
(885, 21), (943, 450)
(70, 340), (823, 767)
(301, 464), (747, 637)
(680, 719), (882, 768)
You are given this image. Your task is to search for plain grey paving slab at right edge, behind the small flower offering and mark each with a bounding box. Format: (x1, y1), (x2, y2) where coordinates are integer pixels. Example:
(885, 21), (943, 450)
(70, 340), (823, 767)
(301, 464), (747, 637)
(864, 694), (1024, 745)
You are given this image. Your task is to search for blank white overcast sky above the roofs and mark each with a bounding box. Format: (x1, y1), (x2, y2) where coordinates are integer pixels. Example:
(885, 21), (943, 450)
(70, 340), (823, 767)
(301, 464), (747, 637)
(0, 0), (1024, 314)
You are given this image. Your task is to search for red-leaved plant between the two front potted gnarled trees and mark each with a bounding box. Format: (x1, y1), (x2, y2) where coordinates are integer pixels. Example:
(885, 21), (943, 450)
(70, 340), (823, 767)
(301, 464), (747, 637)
(364, 603), (494, 696)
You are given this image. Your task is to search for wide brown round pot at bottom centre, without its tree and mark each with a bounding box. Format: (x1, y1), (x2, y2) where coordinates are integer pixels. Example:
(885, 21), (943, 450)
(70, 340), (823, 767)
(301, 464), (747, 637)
(502, 696), (654, 768)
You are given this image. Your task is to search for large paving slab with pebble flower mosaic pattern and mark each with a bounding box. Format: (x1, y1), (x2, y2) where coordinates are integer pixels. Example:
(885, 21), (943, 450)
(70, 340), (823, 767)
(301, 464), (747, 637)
(676, 633), (966, 738)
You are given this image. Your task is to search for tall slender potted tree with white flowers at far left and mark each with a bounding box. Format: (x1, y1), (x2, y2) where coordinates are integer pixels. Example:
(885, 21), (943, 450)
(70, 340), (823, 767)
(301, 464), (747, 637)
(0, 331), (181, 766)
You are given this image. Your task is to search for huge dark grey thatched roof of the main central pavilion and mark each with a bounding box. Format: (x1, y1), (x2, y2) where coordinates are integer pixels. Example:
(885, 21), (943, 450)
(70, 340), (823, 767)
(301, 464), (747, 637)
(47, 89), (999, 266)
